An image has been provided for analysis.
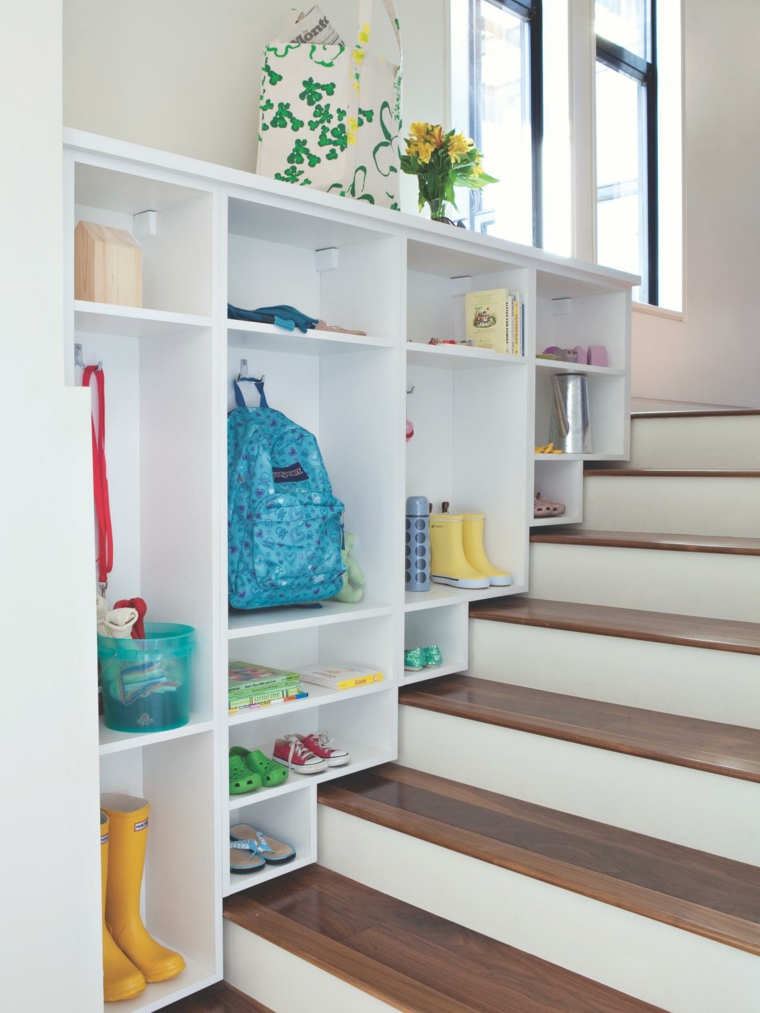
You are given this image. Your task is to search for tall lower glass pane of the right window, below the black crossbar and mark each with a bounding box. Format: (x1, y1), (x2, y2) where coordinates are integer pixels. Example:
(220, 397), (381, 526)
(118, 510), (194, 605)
(597, 62), (645, 289)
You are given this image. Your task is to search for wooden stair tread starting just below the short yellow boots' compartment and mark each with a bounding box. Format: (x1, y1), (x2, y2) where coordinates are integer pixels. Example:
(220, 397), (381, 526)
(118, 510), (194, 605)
(470, 596), (760, 654)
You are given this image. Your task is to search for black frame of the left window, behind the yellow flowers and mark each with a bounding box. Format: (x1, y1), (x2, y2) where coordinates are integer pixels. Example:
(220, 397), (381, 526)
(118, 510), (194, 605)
(467, 0), (543, 247)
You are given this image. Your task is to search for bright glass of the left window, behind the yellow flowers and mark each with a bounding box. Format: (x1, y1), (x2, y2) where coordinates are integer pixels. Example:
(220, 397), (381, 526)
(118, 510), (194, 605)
(474, 0), (533, 245)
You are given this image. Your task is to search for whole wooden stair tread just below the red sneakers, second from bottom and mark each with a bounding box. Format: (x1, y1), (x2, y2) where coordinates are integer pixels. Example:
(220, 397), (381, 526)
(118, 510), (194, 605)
(319, 764), (760, 956)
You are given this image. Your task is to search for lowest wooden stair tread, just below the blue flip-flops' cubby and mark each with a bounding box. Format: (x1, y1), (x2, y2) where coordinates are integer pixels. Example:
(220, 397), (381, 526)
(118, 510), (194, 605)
(224, 865), (662, 1013)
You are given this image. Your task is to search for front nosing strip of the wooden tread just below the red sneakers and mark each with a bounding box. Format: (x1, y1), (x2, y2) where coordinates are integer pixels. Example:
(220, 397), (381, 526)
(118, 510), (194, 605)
(319, 784), (760, 956)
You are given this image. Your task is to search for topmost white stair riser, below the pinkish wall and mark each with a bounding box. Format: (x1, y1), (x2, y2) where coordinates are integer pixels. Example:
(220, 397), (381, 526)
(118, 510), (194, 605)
(628, 415), (760, 471)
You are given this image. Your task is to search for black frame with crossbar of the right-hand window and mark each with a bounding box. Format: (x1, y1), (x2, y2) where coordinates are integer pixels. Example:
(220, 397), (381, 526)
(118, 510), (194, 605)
(596, 0), (660, 306)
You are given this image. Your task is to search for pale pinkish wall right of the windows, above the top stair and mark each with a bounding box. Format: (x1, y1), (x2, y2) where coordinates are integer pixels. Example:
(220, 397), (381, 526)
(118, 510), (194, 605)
(633, 0), (760, 407)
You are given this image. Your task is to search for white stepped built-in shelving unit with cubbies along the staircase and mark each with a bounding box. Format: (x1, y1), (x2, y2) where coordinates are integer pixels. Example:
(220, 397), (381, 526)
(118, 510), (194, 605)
(64, 132), (635, 1013)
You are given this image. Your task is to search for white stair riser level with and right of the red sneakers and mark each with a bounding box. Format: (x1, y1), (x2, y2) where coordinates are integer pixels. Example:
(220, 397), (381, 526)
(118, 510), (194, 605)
(398, 707), (760, 865)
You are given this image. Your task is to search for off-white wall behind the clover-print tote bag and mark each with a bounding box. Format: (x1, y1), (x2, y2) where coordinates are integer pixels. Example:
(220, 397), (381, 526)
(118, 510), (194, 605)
(64, 0), (446, 210)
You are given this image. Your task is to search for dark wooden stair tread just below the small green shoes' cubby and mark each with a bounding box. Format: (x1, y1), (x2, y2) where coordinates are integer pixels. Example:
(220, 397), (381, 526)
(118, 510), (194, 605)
(399, 675), (760, 784)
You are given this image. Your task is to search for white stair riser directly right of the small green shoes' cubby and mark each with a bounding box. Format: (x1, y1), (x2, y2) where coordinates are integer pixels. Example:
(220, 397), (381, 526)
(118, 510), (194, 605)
(469, 619), (760, 728)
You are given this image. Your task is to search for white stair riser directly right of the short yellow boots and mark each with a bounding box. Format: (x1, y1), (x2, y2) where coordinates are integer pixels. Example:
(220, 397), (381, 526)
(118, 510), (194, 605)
(530, 542), (760, 623)
